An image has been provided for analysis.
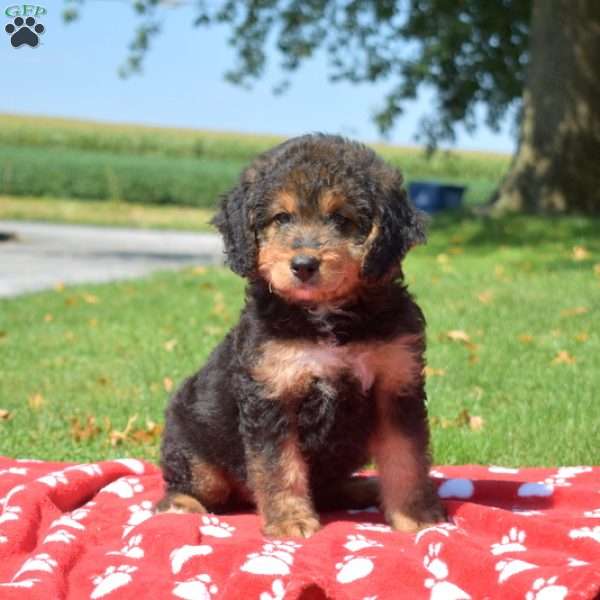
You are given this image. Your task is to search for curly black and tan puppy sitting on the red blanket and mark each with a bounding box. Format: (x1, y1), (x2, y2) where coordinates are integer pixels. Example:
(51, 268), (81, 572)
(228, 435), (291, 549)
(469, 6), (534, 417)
(157, 134), (444, 537)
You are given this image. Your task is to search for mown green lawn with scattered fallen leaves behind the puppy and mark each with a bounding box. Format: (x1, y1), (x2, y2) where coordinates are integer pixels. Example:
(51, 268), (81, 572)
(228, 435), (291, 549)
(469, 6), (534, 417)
(0, 216), (600, 465)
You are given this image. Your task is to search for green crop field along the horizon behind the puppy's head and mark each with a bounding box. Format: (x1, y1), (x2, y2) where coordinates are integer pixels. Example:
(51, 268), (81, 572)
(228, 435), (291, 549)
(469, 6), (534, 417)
(0, 115), (509, 208)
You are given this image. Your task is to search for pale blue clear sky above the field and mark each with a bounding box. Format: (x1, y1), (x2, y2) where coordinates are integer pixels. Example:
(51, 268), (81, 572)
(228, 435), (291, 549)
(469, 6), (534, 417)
(0, 0), (515, 153)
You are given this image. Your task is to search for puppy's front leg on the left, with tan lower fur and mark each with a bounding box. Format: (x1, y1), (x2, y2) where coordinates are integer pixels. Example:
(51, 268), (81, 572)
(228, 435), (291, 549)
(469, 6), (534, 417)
(241, 397), (319, 537)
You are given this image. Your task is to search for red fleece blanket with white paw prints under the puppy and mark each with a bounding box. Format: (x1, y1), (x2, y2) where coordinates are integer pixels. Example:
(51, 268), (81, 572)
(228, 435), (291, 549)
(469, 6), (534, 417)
(0, 458), (600, 600)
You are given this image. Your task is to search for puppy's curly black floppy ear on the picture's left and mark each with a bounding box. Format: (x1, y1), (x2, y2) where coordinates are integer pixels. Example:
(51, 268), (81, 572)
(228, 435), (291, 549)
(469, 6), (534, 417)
(211, 181), (257, 277)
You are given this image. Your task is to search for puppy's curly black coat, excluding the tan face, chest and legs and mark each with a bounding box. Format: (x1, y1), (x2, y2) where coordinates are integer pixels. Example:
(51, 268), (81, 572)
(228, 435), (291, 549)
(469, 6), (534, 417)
(160, 134), (439, 532)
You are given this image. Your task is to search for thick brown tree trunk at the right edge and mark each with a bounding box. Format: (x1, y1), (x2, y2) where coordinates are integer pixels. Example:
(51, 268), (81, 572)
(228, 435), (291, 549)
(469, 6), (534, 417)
(492, 0), (600, 214)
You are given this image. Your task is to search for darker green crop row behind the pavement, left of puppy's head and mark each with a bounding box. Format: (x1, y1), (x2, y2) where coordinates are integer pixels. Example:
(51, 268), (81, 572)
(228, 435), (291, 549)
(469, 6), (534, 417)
(0, 146), (244, 208)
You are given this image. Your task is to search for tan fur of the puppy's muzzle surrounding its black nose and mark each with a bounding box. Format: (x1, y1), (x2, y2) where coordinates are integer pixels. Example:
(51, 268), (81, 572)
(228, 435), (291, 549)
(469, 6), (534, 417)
(258, 241), (361, 302)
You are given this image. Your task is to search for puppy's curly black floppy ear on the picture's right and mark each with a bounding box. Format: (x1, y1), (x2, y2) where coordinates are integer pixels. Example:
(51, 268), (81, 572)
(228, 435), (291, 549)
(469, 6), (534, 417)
(362, 185), (426, 279)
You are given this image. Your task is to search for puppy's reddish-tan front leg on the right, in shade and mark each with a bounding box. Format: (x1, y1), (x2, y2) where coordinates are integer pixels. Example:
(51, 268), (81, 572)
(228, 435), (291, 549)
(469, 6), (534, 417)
(372, 386), (445, 532)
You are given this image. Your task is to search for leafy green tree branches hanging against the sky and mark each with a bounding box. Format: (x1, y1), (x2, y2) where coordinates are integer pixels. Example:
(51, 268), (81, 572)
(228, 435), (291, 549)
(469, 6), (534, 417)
(64, 0), (531, 148)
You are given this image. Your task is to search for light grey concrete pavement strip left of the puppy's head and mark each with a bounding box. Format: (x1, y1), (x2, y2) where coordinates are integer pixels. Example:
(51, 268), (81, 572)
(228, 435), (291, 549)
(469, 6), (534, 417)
(0, 221), (223, 297)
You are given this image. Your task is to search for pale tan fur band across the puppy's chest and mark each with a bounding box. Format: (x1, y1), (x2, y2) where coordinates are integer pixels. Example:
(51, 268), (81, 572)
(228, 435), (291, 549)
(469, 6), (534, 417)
(252, 335), (420, 399)
